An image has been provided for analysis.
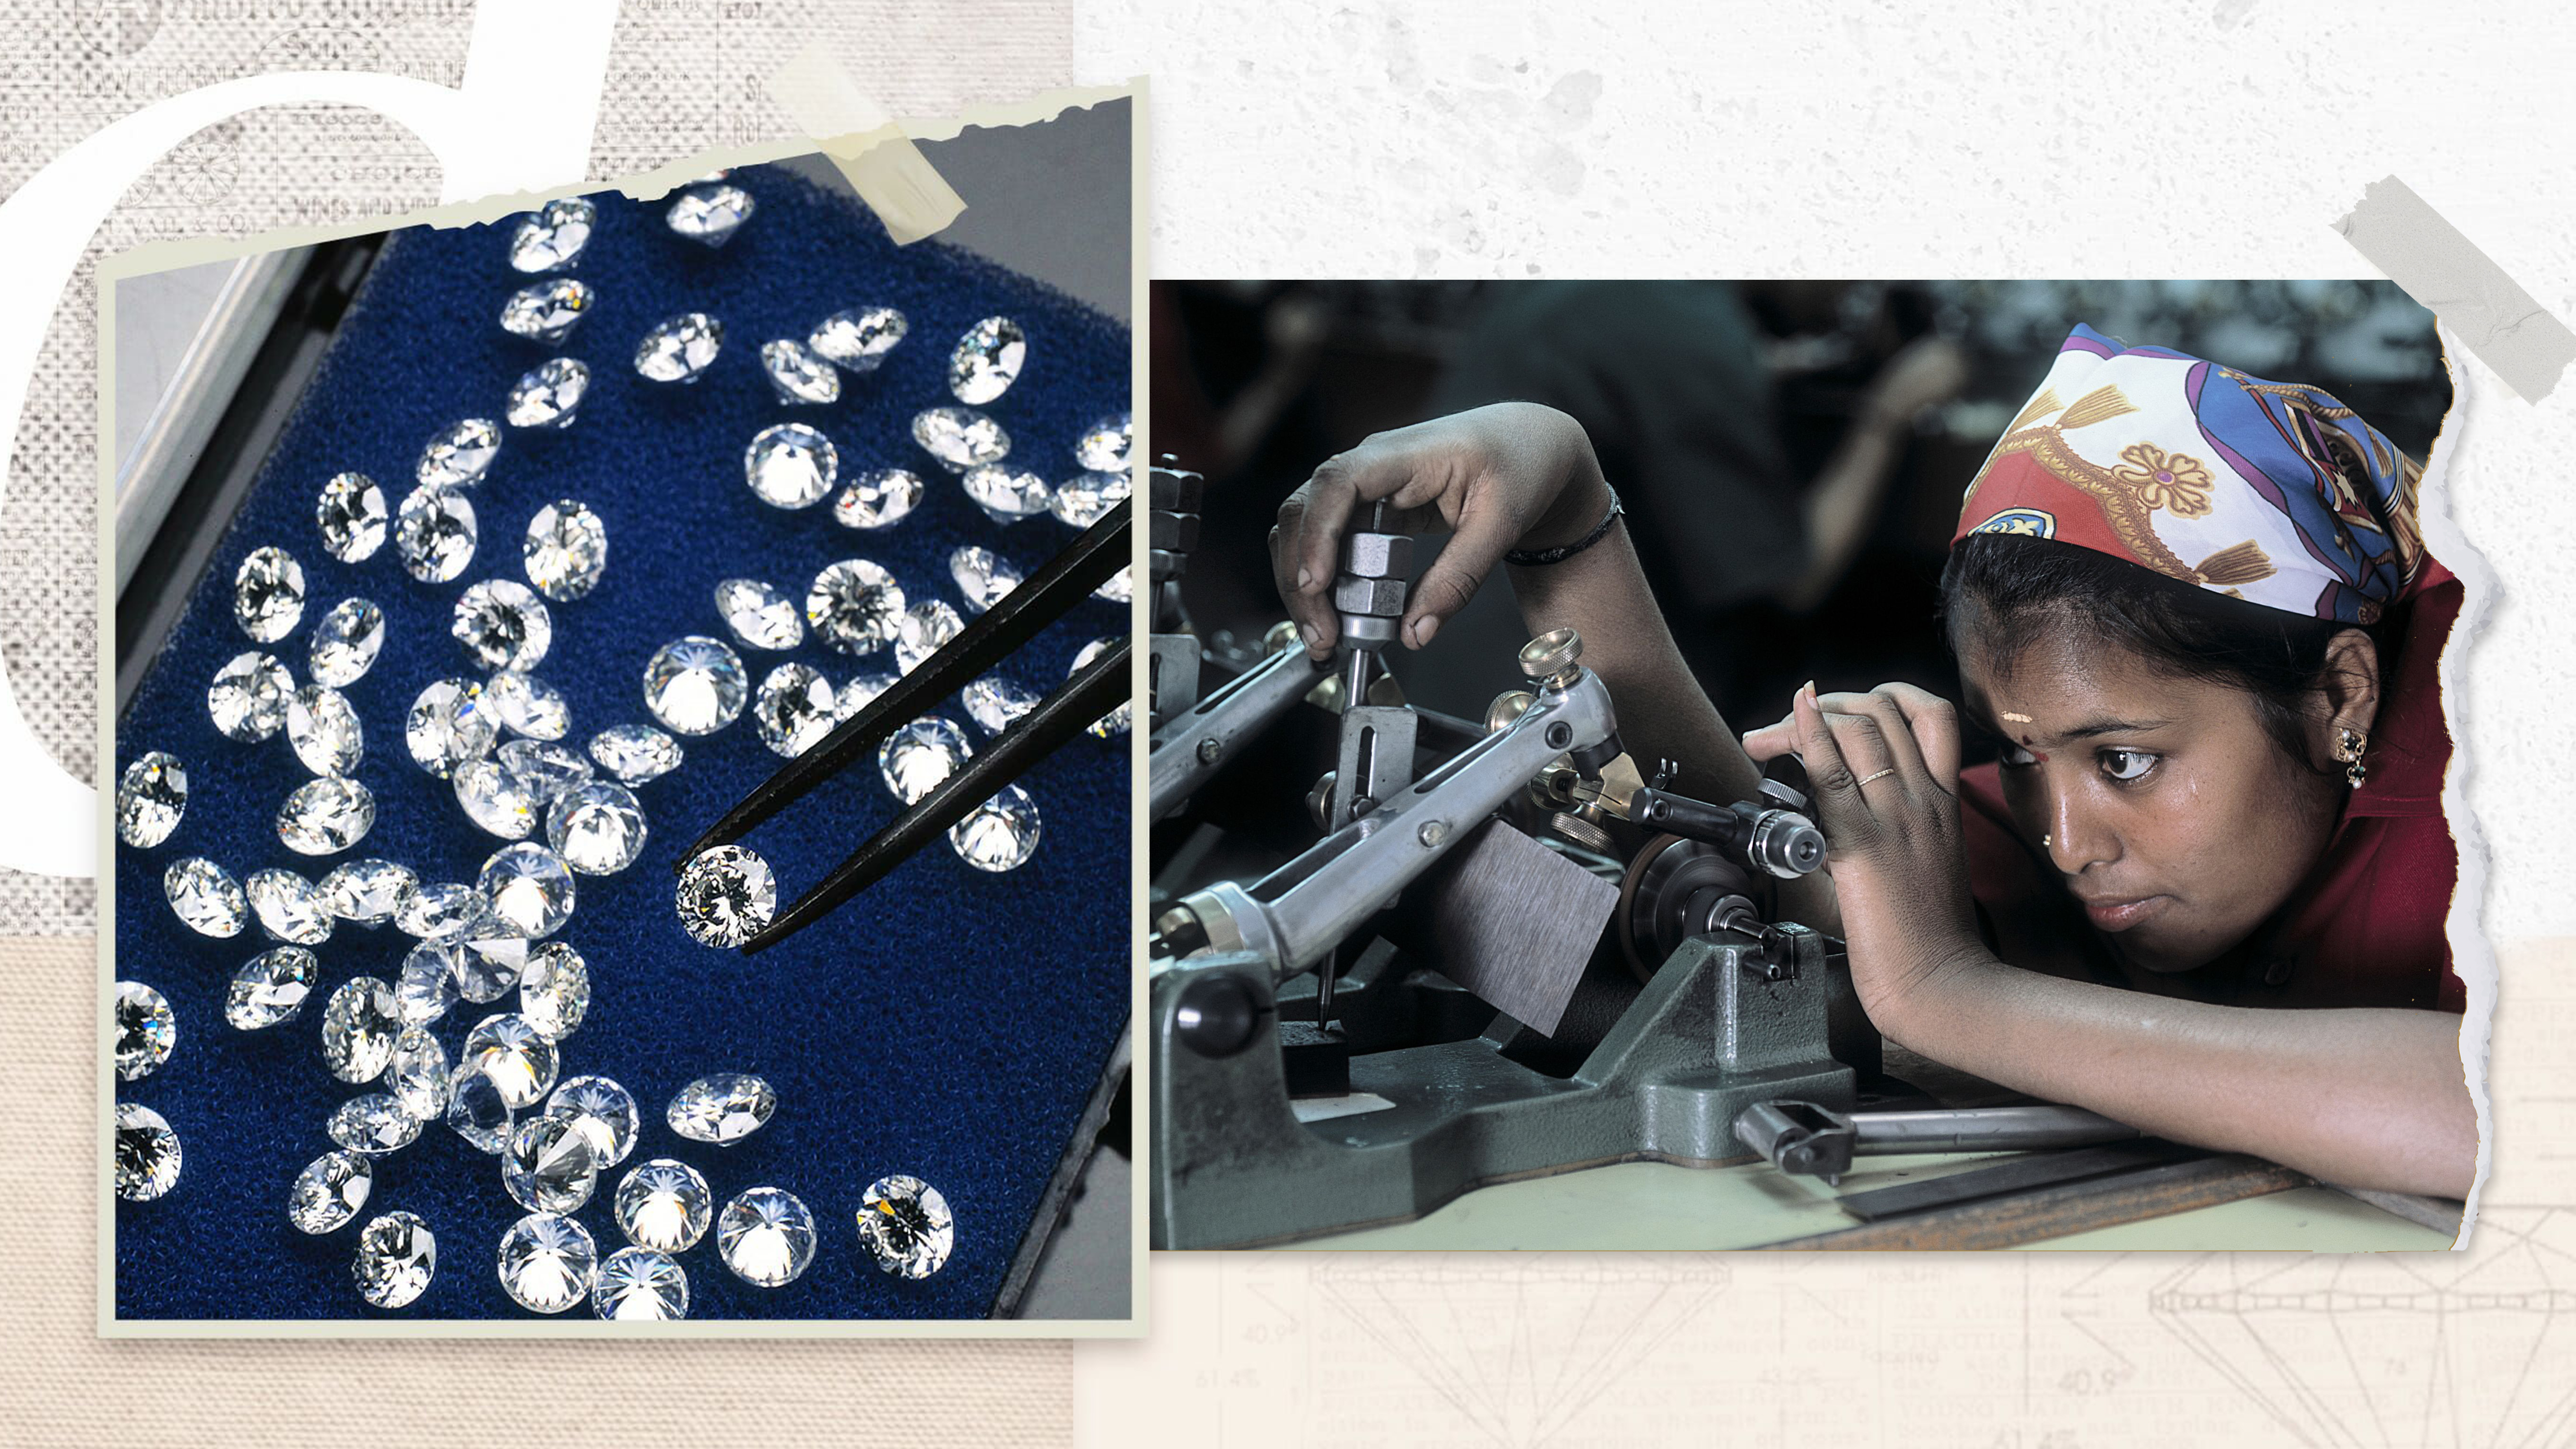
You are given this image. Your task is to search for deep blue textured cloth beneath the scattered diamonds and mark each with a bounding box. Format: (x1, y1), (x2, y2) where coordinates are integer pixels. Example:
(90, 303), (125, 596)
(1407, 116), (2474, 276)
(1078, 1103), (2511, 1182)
(116, 168), (1131, 1320)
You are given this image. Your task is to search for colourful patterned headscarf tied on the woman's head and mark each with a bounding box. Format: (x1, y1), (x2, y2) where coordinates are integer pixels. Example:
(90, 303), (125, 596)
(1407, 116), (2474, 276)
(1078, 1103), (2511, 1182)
(1950, 325), (2424, 624)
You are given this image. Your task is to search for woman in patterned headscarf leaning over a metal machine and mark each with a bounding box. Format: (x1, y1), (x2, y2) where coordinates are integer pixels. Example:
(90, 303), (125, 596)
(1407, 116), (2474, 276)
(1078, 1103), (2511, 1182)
(1270, 328), (2478, 1196)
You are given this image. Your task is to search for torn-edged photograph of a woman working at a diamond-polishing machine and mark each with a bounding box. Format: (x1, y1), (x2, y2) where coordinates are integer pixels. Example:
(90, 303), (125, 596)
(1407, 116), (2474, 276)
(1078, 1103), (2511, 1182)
(1146, 281), (2478, 1253)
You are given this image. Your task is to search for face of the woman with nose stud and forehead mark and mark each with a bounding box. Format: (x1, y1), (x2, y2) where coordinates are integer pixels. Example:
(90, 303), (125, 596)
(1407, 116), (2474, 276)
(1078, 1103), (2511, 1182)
(1960, 627), (2337, 972)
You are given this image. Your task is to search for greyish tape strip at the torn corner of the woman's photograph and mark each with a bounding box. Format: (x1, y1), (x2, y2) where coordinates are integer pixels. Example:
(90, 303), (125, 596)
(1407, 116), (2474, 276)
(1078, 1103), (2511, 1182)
(2334, 175), (2576, 402)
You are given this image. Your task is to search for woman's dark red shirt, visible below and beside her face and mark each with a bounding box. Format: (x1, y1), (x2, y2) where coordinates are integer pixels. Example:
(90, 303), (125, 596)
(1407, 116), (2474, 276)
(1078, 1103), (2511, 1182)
(1958, 560), (2468, 1011)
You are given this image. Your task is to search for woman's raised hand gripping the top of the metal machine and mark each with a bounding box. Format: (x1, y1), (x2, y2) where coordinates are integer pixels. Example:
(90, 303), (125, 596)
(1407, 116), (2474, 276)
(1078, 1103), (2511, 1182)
(1270, 402), (1610, 660)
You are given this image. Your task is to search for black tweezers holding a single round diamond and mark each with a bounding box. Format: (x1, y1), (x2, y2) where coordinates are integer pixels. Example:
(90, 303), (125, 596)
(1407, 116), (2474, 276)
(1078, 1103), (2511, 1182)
(678, 500), (1133, 957)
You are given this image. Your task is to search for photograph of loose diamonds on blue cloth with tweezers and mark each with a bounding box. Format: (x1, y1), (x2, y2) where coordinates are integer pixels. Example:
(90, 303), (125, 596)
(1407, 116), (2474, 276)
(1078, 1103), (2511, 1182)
(100, 96), (1141, 1335)
